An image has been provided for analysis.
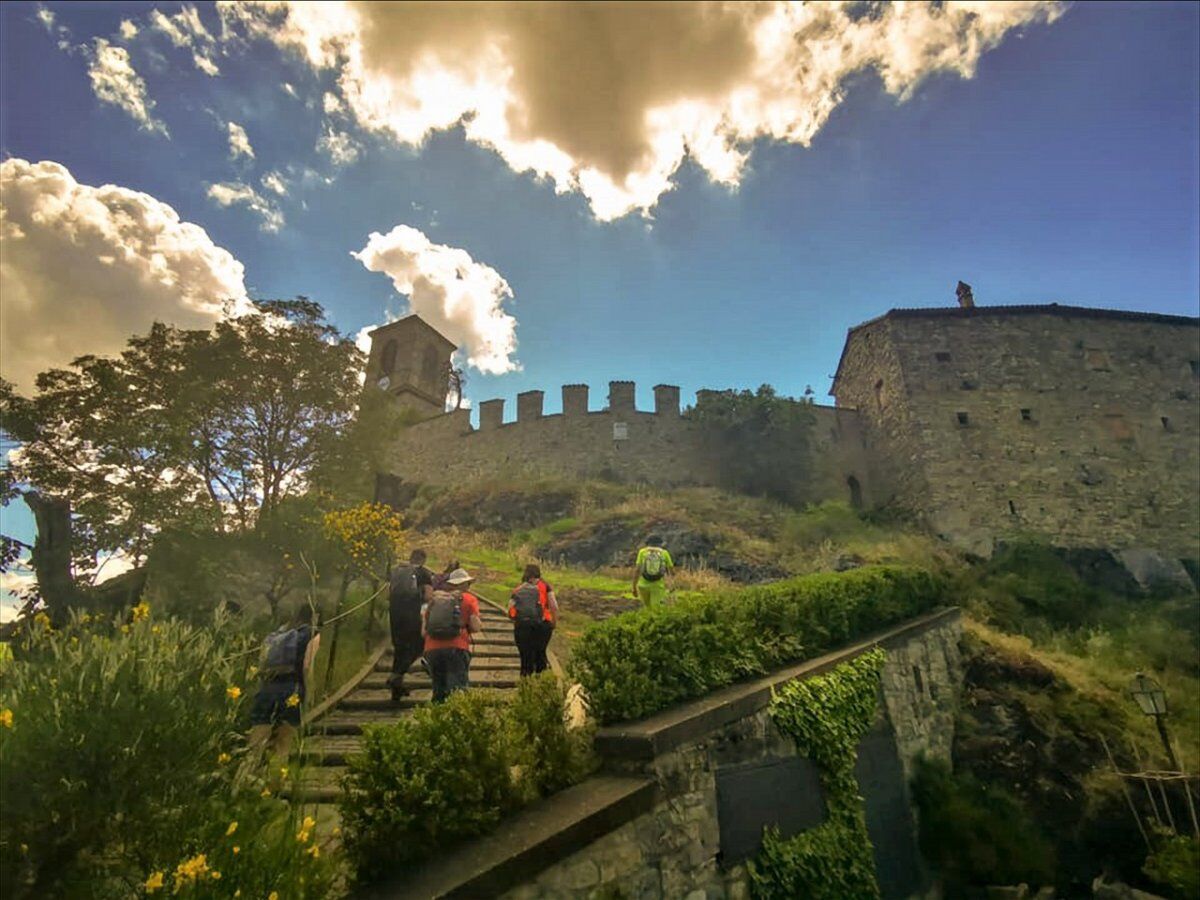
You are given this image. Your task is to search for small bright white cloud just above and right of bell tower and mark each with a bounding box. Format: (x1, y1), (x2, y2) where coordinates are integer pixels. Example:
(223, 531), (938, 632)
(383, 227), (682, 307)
(350, 226), (520, 374)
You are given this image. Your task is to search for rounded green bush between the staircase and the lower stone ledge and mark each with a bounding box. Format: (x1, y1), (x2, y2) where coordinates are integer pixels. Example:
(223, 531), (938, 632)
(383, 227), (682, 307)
(340, 673), (590, 882)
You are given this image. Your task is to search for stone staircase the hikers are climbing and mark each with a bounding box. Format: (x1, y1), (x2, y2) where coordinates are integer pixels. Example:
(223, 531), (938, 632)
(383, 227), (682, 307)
(293, 602), (521, 818)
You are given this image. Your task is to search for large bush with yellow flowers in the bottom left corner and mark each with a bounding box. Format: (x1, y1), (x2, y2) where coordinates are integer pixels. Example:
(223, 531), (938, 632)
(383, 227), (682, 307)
(0, 604), (343, 898)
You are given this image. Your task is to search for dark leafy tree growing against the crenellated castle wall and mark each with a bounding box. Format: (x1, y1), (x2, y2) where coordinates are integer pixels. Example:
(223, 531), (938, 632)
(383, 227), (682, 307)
(688, 384), (814, 503)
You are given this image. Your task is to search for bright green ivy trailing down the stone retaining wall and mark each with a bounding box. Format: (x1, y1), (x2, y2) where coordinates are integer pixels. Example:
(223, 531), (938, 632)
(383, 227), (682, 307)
(750, 648), (886, 900)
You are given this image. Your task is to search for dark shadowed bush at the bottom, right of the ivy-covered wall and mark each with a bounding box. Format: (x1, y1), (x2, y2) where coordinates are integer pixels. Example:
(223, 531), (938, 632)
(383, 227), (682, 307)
(913, 760), (1055, 896)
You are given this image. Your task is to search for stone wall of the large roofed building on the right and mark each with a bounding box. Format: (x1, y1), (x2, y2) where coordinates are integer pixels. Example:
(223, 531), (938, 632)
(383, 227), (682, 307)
(834, 307), (1200, 557)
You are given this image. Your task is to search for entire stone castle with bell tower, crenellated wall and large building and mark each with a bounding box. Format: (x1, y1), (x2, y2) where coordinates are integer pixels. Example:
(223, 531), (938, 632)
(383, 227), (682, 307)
(367, 300), (1200, 559)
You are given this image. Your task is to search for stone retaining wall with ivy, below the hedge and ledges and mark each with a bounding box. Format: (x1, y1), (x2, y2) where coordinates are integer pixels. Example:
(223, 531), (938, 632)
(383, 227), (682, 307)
(503, 613), (961, 900)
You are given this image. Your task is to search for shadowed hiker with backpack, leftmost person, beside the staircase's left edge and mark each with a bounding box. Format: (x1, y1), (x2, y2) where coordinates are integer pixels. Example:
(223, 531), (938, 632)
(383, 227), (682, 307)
(247, 606), (320, 760)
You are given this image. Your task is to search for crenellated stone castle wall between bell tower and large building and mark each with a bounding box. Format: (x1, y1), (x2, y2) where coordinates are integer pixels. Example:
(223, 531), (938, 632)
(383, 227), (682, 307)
(381, 382), (871, 504)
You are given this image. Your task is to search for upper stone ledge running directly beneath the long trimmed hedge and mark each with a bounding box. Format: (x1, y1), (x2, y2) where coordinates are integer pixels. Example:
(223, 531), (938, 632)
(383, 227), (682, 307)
(595, 607), (961, 762)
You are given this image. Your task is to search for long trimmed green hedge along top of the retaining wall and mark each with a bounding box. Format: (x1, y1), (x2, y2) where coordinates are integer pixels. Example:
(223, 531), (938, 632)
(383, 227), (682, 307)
(570, 566), (947, 722)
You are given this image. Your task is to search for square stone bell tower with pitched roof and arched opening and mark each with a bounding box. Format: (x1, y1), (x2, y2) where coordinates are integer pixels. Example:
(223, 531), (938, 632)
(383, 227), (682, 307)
(367, 314), (457, 415)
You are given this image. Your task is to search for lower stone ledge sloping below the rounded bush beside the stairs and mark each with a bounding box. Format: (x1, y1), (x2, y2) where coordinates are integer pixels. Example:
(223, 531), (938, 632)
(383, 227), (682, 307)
(367, 775), (655, 900)
